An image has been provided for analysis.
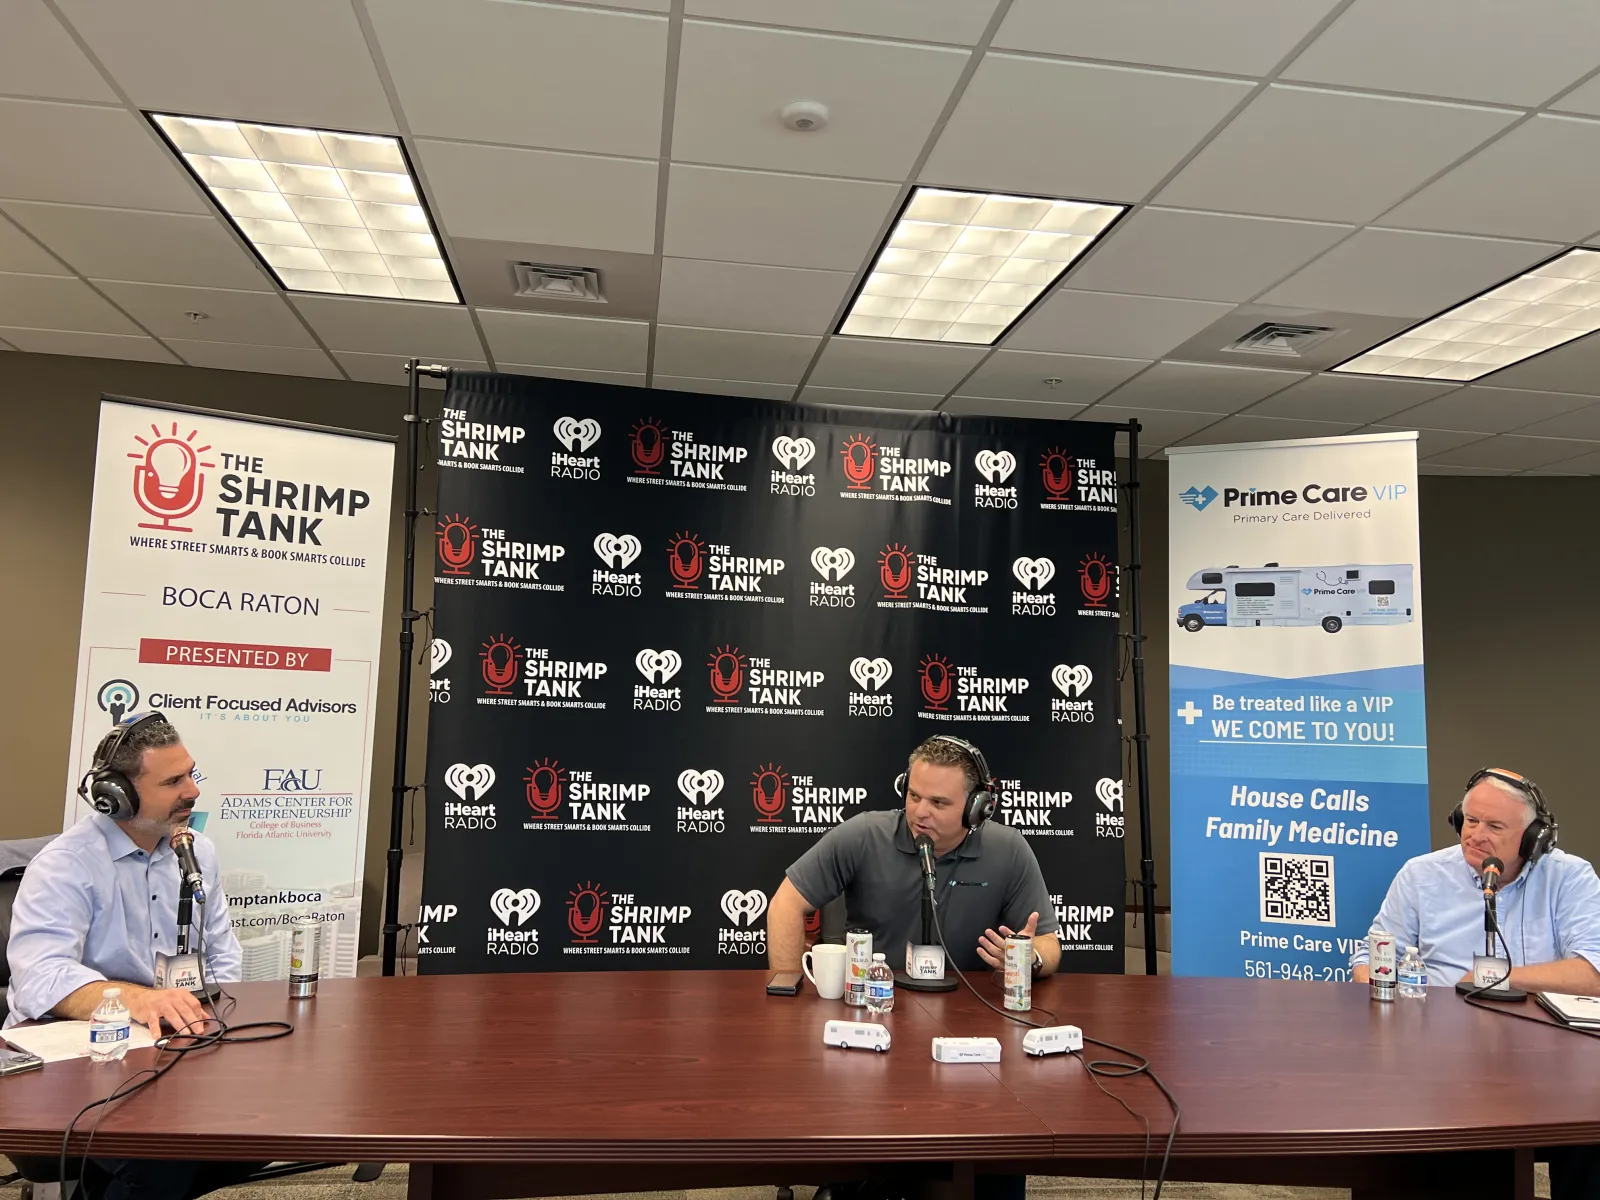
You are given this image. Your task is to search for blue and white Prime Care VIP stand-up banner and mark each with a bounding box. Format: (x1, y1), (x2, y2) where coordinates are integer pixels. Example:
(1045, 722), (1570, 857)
(1166, 434), (1429, 981)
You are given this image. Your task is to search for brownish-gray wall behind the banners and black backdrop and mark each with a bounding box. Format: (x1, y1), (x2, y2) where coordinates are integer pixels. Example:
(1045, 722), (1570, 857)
(0, 354), (1600, 952)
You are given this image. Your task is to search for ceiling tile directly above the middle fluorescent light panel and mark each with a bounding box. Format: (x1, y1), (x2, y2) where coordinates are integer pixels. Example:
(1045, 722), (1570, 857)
(922, 54), (1251, 206)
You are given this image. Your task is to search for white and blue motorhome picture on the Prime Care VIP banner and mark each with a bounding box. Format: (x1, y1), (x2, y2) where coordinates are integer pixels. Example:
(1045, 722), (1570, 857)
(1178, 563), (1416, 634)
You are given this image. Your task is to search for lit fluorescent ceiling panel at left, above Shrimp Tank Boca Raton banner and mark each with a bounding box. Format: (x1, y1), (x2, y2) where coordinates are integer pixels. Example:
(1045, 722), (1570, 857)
(150, 112), (461, 304)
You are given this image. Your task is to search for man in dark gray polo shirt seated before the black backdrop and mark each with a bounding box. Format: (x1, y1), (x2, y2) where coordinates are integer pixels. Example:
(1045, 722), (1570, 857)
(766, 734), (1061, 976)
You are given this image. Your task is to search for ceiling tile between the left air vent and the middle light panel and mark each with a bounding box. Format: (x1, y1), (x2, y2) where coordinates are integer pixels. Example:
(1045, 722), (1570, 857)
(658, 258), (854, 333)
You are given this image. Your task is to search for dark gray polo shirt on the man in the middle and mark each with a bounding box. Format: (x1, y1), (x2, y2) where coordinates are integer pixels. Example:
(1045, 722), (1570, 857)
(787, 808), (1061, 971)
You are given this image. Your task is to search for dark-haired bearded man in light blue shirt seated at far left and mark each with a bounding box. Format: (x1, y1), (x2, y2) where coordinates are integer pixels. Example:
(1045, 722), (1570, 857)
(5, 712), (243, 1035)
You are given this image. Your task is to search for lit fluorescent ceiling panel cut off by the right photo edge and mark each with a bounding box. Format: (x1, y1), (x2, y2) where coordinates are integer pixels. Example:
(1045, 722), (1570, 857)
(1333, 250), (1600, 379)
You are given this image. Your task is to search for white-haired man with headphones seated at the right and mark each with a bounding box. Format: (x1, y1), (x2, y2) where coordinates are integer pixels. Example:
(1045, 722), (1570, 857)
(1350, 768), (1600, 995)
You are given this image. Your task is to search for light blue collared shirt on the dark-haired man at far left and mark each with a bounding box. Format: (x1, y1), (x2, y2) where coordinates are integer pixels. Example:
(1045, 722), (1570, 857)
(5, 813), (243, 1026)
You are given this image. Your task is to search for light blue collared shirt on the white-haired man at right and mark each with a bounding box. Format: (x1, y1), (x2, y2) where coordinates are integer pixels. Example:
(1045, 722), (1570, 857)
(1350, 846), (1600, 987)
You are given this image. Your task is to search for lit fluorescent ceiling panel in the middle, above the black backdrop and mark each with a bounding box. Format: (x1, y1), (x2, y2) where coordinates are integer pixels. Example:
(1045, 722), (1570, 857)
(838, 187), (1128, 346)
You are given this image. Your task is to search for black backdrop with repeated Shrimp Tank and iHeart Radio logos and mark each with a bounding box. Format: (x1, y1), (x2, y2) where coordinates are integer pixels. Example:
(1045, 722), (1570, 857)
(418, 374), (1123, 973)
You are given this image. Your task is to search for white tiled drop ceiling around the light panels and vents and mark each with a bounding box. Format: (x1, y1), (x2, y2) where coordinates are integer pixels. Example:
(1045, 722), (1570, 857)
(0, 0), (1600, 475)
